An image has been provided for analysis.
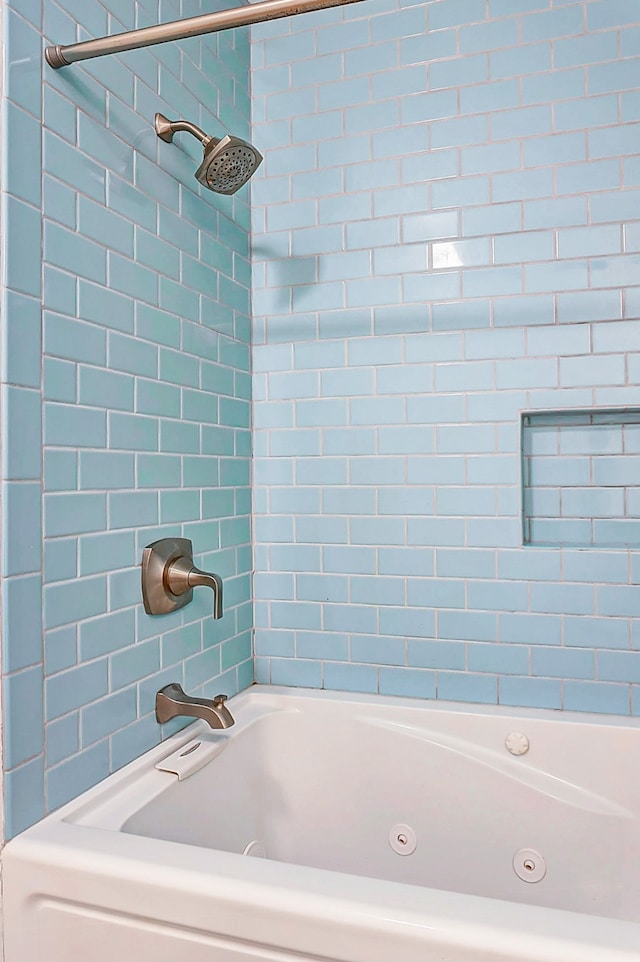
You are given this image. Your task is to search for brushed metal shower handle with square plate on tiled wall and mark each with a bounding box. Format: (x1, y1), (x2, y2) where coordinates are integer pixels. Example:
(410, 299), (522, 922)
(142, 538), (223, 618)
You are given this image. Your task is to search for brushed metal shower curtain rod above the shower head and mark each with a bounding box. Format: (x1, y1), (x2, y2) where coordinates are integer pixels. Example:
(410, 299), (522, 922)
(44, 0), (362, 70)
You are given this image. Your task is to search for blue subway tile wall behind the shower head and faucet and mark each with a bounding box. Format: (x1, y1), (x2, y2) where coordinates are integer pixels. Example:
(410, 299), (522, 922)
(2, 0), (253, 835)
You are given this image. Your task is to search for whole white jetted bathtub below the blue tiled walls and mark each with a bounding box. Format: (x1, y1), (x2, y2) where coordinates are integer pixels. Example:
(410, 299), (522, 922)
(4, 688), (640, 962)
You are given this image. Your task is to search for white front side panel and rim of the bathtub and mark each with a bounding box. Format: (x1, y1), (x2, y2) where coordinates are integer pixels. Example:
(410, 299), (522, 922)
(5, 826), (640, 962)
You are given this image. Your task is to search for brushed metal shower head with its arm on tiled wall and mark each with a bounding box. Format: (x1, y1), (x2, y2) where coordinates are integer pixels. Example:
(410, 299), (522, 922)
(155, 114), (262, 194)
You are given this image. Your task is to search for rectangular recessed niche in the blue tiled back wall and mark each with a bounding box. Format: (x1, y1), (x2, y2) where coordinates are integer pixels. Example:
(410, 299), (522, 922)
(522, 408), (640, 548)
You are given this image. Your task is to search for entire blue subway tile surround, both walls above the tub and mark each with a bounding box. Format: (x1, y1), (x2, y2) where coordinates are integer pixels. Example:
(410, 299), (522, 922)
(2, 0), (640, 835)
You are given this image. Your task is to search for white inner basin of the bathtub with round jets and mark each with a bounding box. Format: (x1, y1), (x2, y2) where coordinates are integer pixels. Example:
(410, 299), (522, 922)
(69, 689), (640, 921)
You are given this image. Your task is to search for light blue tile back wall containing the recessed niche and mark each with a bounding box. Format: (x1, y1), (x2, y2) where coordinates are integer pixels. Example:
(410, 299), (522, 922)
(252, 0), (640, 714)
